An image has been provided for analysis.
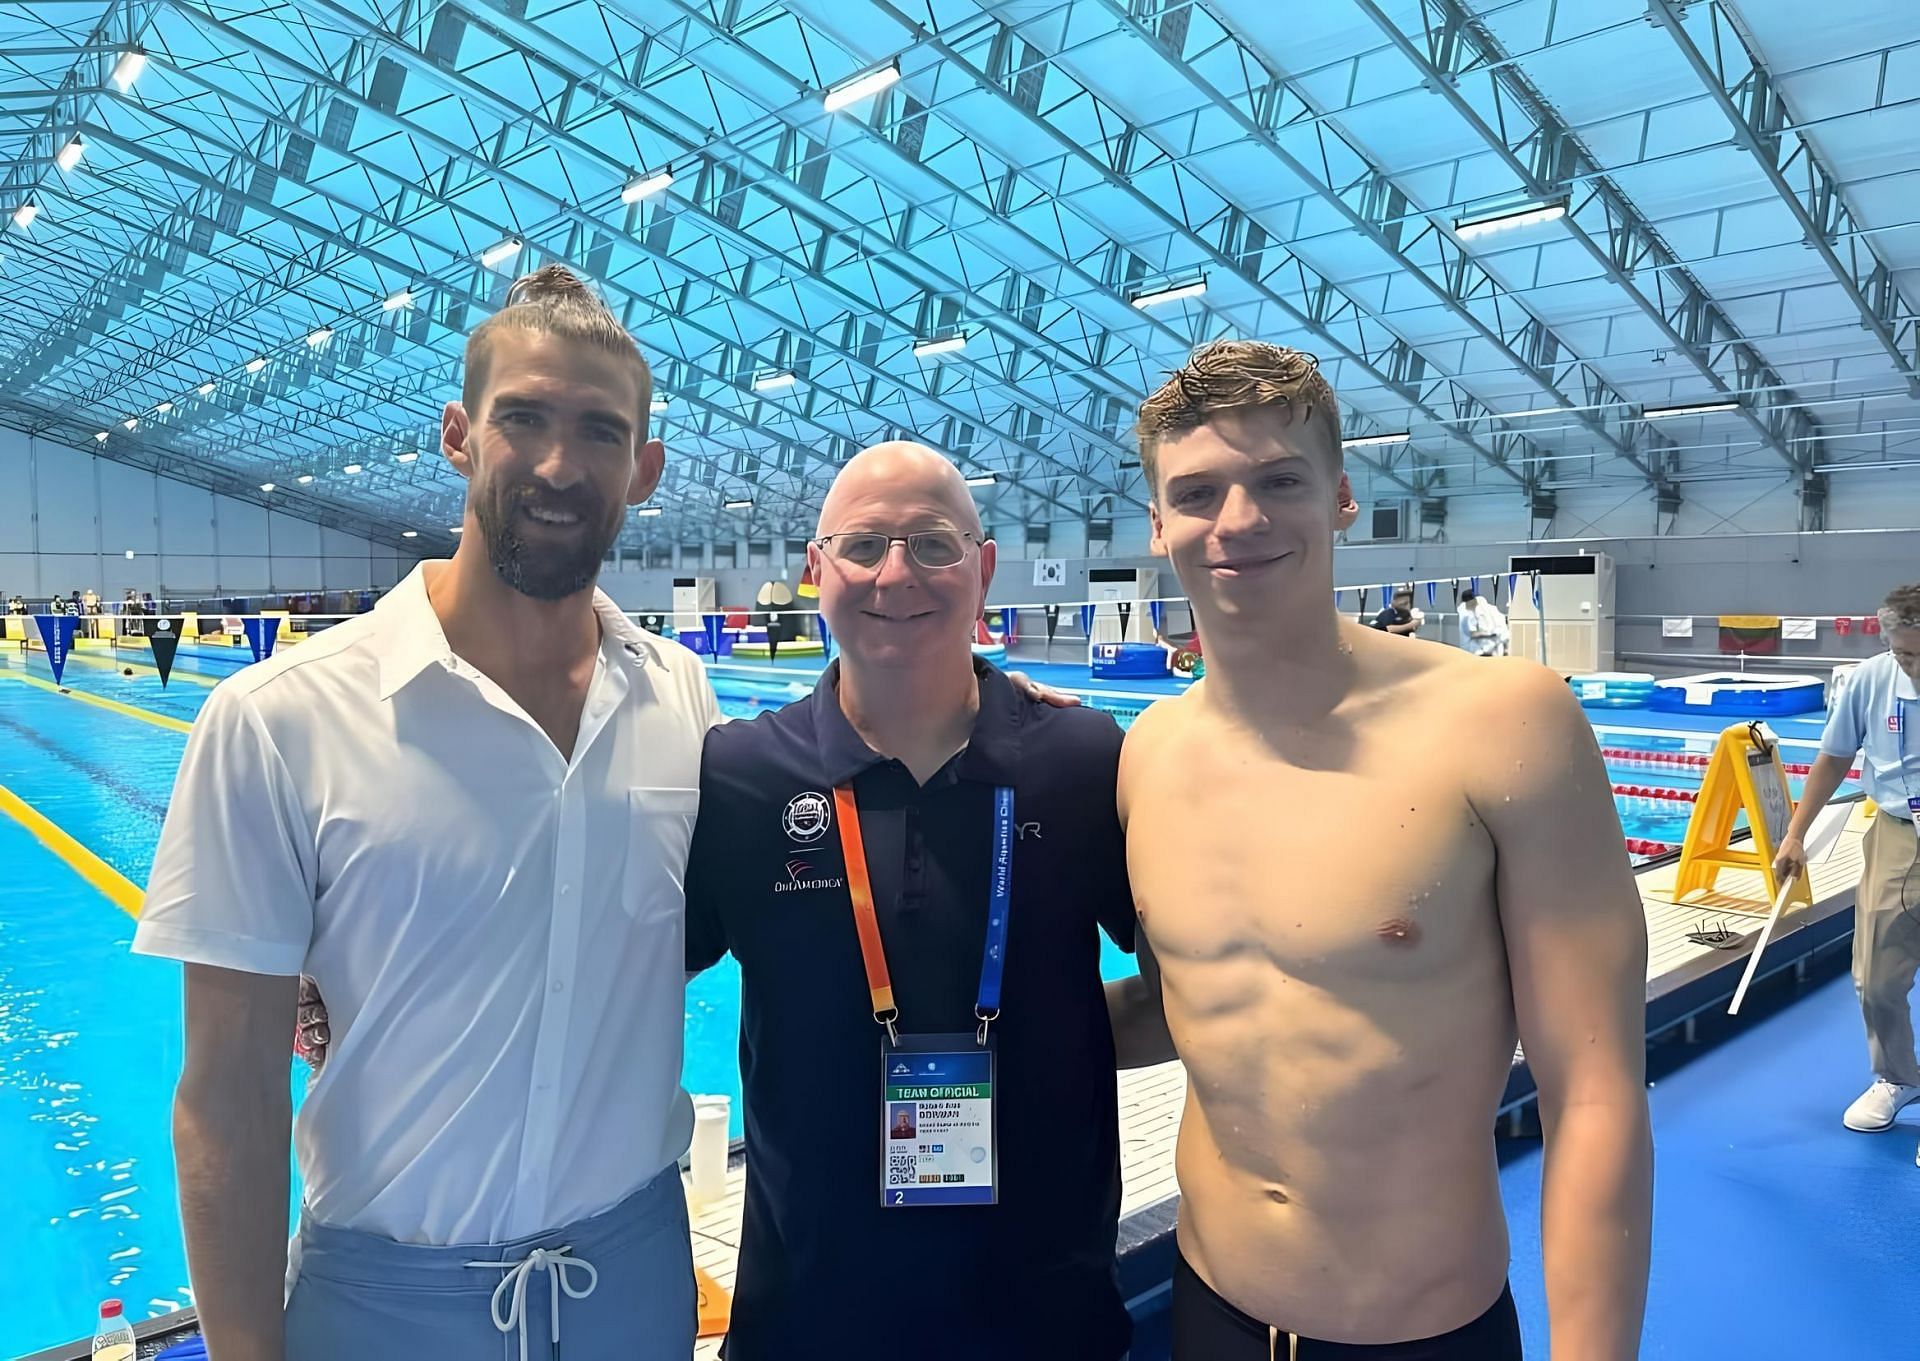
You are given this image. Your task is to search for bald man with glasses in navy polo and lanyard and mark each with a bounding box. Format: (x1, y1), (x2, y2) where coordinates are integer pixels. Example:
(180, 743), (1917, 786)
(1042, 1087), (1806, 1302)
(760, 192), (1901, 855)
(685, 443), (1133, 1361)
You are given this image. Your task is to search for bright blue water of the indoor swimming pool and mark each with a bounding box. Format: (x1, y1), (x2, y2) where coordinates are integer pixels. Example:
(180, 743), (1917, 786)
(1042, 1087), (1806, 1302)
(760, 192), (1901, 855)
(0, 645), (1843, 1355)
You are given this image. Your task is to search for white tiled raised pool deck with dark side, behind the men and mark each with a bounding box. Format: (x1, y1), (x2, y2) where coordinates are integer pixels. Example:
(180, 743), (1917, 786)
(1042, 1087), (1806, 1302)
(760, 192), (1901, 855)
(23, 802), (1866, 1361)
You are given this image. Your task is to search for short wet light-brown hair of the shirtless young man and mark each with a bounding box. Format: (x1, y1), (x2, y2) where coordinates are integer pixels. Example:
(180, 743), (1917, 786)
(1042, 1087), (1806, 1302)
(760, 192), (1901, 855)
(1135, 340), (1340, 491)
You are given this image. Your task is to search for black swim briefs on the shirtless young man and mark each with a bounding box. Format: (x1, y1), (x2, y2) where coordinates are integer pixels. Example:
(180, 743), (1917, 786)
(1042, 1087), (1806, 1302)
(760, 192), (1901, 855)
(1173, 1257), (1523, 1361)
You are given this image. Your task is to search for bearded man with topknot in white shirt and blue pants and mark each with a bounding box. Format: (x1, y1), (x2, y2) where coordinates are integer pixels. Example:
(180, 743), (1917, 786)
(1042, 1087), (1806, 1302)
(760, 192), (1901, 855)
(134, 267), (718, 1361)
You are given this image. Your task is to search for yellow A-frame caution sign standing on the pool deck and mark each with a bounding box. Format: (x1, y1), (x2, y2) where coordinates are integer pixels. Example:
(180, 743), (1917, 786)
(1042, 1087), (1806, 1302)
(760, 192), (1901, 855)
(1674, 724), (1812, 916)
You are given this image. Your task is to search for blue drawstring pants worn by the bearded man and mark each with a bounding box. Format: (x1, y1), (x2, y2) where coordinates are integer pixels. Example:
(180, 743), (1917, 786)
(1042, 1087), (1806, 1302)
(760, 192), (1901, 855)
(286, 1167), (695, 1361)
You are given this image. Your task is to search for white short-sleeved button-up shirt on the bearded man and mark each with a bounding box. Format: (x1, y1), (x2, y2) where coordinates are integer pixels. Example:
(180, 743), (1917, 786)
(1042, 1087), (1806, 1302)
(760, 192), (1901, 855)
(134, 568), (720, 1244)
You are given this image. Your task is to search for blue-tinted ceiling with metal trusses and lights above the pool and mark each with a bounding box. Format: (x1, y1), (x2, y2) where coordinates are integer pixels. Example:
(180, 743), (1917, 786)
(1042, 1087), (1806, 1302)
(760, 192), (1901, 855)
(0, 0), (1920, 547)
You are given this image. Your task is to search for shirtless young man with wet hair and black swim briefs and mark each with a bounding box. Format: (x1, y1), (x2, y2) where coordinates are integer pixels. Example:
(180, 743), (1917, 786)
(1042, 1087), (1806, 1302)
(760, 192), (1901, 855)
(1116, 342), (1653, 1361)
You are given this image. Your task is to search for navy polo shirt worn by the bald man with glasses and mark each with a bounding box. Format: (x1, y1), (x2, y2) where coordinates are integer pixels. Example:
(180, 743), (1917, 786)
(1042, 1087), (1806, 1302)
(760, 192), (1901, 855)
(685, 662), (1135, 1361)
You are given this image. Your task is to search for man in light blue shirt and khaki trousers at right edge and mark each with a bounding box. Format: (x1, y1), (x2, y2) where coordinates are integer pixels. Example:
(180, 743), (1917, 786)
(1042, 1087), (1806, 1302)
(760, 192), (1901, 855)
(1774, 584), (1920, 1133)
